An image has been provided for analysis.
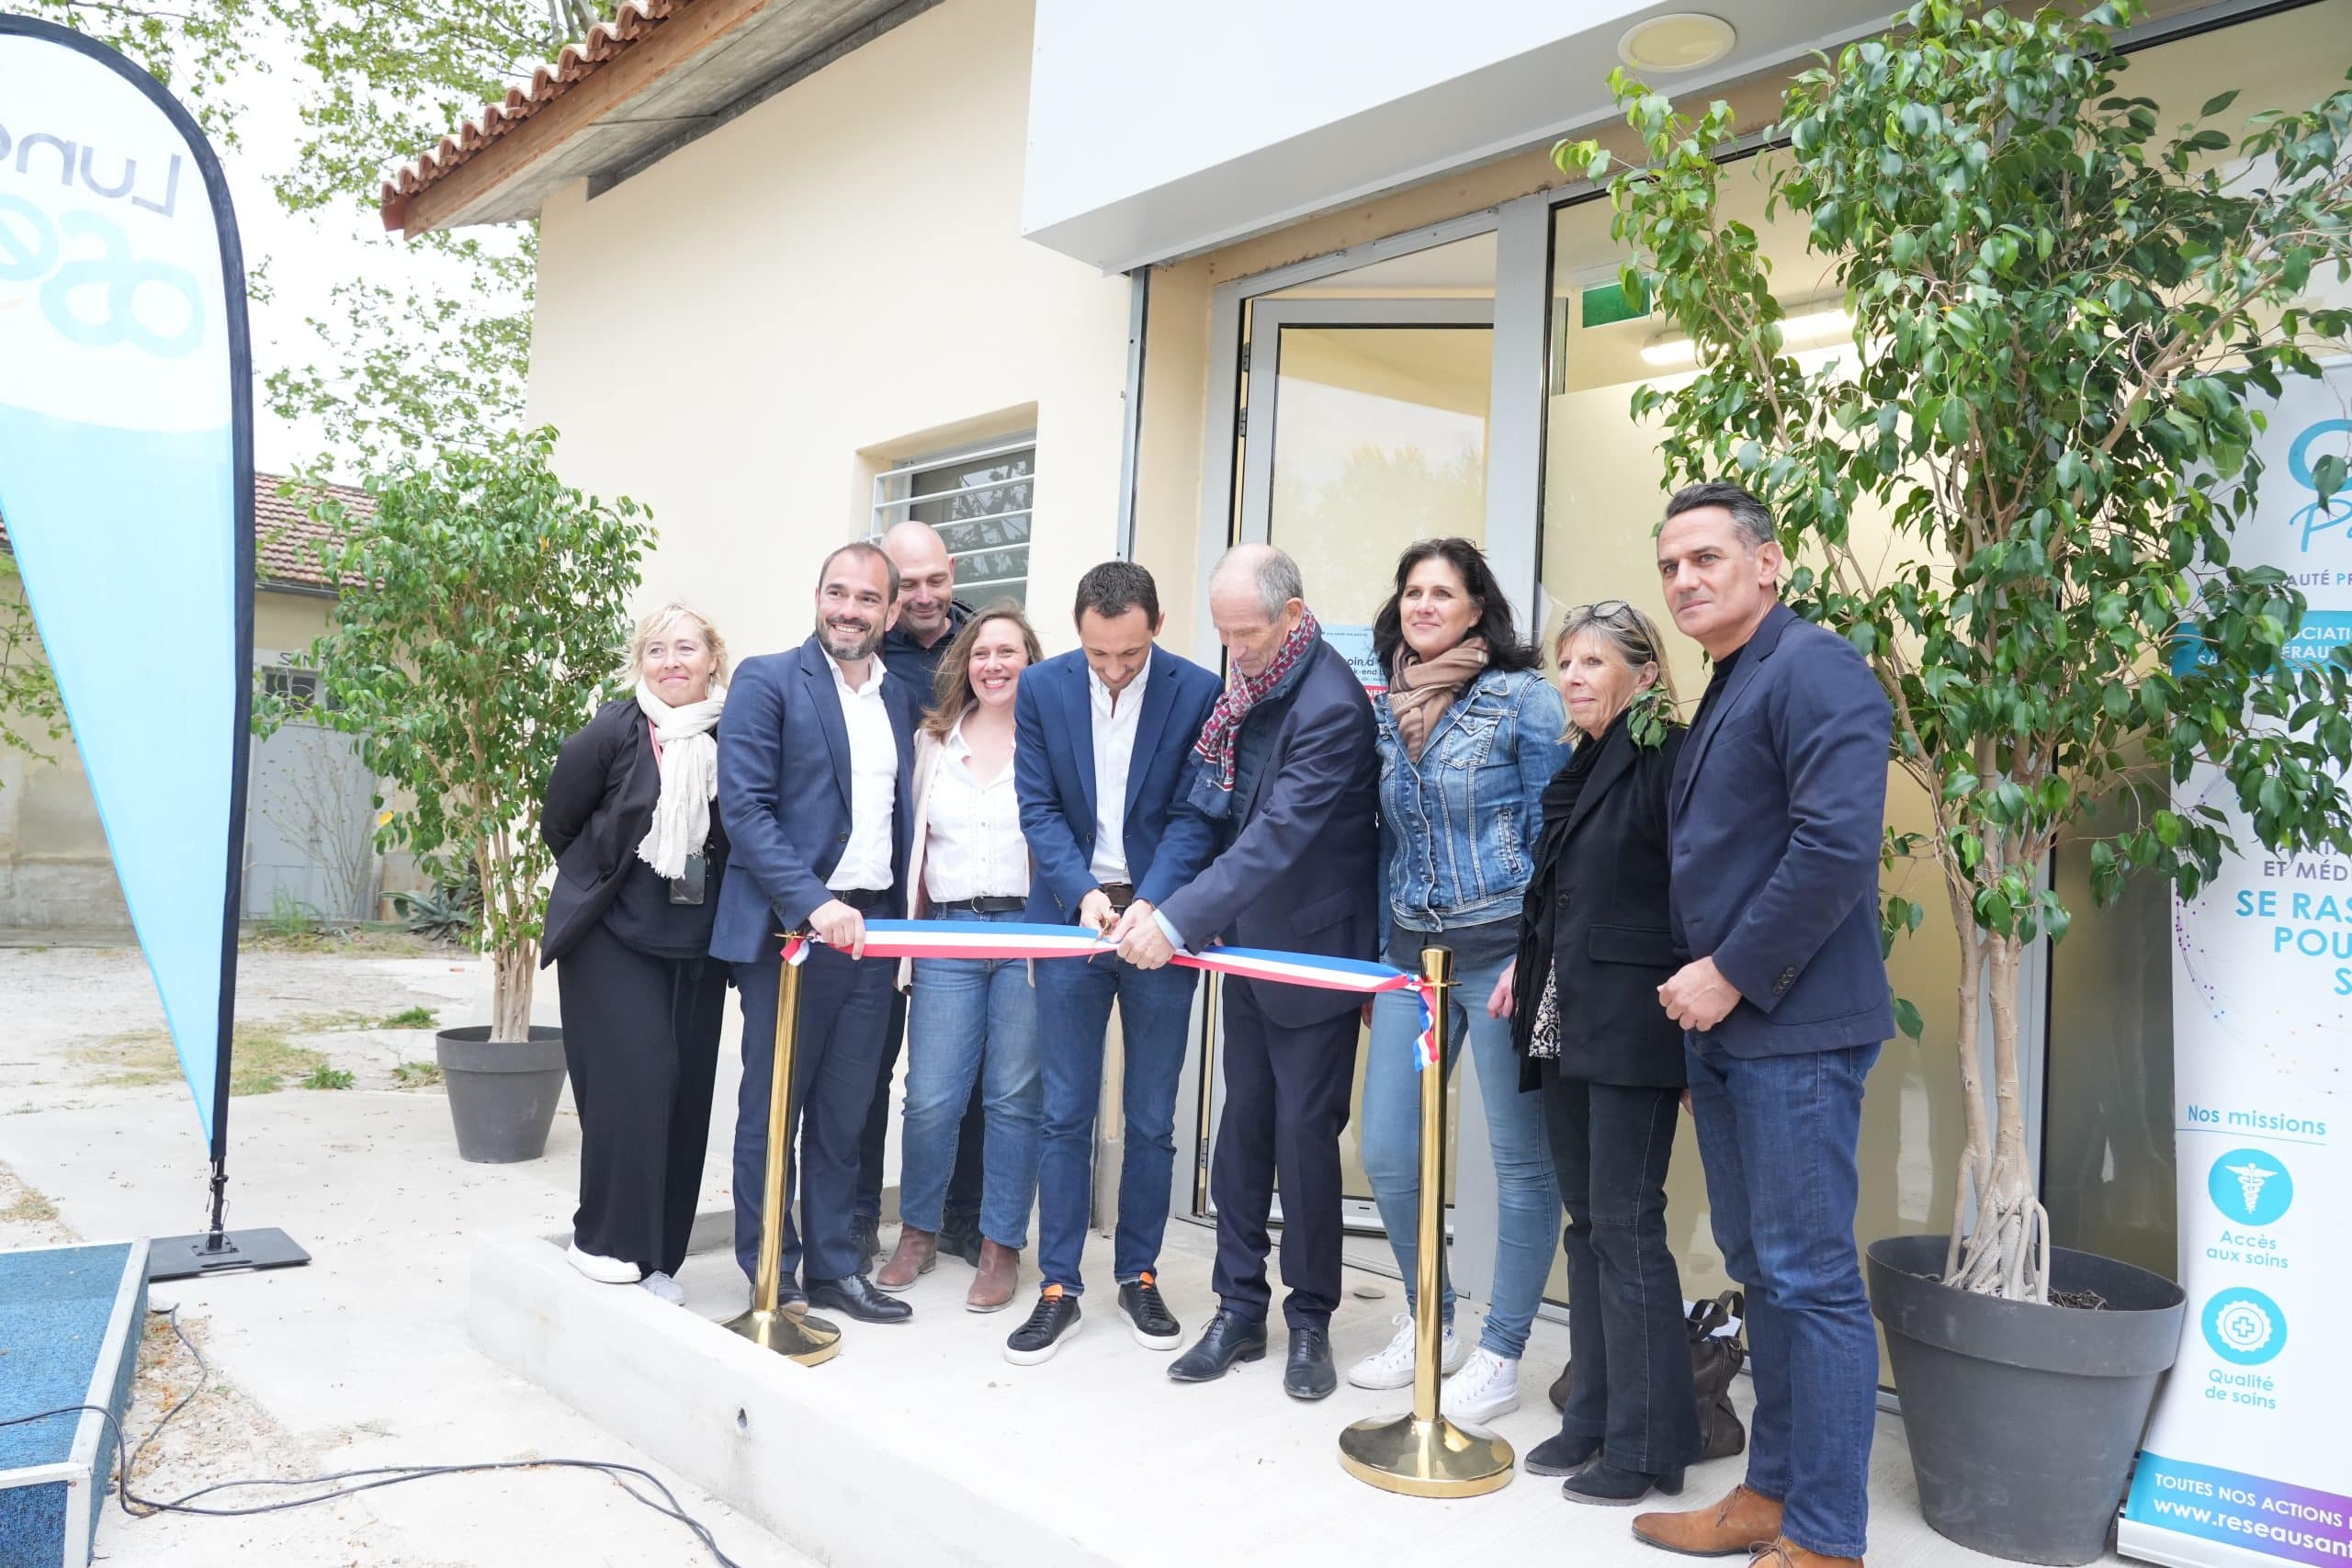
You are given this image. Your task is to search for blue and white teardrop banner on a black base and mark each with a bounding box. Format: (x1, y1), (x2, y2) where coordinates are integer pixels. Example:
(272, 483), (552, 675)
(0, 14), (308, 1279)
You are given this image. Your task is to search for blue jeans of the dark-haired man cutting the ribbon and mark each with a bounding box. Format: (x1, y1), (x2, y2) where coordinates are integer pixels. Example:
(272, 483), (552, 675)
(1037, 957), (1200, 1295)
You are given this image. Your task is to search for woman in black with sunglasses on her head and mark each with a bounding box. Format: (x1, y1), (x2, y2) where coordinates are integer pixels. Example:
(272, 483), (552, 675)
(1505, 600), (1698, 1505)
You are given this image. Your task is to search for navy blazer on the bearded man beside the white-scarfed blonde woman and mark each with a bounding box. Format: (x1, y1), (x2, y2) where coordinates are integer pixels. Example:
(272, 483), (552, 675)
(710, 635), (920, 964)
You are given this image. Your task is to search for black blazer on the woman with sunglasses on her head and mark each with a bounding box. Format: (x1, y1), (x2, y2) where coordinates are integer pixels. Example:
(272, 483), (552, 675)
(1510, 724), (1687, 1089)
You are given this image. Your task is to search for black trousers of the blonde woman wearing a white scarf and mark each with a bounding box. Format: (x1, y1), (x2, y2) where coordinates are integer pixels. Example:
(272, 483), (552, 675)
(555, 924), (727, 1274)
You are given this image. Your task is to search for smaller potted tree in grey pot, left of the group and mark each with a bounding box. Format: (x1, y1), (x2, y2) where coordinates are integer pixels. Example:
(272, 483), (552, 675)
(276, 430), (654, 1164)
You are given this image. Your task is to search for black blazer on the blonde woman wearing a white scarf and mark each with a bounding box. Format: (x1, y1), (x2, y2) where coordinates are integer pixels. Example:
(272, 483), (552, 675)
(538, 696), (727, 968)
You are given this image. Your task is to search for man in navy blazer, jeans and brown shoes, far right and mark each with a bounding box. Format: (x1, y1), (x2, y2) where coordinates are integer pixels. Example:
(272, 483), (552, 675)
(1634, 484), (1894, 1568)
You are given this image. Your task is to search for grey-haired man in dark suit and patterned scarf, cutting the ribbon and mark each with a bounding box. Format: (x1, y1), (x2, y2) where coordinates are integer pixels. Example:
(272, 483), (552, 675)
(1113, 546), (1381, 1399)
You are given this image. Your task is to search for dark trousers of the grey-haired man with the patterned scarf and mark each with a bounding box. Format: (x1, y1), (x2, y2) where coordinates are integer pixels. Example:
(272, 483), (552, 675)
(1209, 980), (1357, 1328)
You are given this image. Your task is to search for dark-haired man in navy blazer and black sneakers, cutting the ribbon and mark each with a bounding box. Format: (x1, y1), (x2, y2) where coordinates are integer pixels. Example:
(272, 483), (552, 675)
(1004, 562), (1218, 1366)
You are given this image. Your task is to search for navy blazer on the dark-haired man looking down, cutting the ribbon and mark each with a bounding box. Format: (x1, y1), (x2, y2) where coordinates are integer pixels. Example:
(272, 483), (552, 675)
(1013, 647), (1221, 924)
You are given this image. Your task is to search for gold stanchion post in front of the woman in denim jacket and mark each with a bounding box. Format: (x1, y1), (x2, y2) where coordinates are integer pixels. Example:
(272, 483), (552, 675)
(1339, 947), (1512, 1497)
